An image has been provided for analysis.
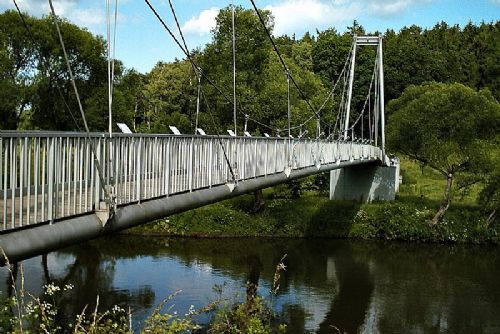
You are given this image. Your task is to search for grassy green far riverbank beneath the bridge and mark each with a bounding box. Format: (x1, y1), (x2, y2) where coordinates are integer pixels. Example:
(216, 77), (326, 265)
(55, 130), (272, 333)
(126, 160), (500, 244)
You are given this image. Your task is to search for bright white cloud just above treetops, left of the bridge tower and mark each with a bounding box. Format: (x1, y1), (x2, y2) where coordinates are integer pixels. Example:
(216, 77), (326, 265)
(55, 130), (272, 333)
(265, 0), (362, 35)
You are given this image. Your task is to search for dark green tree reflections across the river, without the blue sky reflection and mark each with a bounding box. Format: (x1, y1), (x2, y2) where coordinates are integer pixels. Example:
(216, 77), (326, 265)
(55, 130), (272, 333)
(4, 236), (500, 333)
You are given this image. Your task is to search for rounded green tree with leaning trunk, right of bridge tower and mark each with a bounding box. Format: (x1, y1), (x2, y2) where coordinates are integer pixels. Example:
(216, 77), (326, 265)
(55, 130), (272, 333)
(387, 82), (500, 225)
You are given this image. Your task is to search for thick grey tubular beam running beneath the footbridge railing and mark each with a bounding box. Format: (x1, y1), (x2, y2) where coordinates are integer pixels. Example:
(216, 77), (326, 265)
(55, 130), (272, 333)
(0, 160), (380, 262)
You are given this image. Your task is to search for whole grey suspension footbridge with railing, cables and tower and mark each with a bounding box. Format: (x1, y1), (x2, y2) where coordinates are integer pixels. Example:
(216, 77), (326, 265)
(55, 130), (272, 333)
(0, 0), (398, 261)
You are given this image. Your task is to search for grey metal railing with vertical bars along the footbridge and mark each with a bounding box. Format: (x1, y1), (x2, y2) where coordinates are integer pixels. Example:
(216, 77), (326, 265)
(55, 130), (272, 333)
(0, 131), (382, 231)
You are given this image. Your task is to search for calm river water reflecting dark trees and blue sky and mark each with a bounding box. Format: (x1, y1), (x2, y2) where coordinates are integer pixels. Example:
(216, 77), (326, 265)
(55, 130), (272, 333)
(0, 236), (500, 333)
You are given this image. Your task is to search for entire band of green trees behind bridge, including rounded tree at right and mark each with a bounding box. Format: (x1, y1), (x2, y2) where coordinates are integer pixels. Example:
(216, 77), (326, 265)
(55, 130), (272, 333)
(0, 7), (500, 223)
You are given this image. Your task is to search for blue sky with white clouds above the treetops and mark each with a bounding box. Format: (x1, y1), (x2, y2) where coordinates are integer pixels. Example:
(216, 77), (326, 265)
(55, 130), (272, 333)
(0, 0), (500, 73)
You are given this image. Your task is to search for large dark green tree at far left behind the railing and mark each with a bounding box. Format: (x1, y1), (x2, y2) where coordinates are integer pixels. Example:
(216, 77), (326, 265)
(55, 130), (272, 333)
(0, 11), (114, 130)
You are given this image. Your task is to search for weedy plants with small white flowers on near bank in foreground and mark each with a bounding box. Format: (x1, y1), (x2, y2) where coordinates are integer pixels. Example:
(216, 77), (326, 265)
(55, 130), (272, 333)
(0, 262), (286, 334)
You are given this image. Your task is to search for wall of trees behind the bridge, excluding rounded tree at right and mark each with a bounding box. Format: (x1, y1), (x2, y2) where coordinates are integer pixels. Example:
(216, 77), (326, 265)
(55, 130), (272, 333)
(0, 7), (500, 134)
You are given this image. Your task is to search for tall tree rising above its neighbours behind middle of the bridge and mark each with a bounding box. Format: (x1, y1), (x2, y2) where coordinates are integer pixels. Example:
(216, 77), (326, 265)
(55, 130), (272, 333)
(199, 6), (274, 132)
